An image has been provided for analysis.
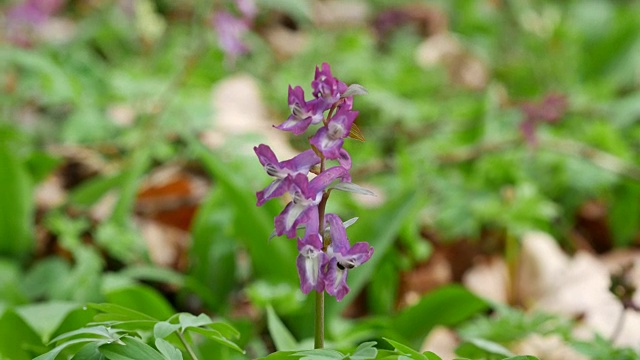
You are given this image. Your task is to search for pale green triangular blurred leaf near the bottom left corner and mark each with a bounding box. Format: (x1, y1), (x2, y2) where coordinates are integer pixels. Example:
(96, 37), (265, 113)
(15, 301), (79, 344)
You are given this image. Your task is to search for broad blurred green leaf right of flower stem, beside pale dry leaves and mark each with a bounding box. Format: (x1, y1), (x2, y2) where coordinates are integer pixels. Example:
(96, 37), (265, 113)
(392, 285), (488, 346)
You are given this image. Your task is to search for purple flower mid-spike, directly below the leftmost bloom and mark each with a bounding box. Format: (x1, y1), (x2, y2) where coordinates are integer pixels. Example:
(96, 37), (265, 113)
(275, 166), (351, 239)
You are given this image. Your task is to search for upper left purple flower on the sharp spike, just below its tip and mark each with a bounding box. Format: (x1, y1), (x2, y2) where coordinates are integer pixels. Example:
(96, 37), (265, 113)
(275, 86), (324, 135)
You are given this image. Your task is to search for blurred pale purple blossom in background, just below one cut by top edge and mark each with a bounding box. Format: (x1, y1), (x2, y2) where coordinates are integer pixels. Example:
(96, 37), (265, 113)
(212, 11), (249, 59)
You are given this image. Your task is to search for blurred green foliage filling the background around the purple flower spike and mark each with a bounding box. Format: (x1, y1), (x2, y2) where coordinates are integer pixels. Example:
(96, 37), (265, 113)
(0, 0), (640, 360)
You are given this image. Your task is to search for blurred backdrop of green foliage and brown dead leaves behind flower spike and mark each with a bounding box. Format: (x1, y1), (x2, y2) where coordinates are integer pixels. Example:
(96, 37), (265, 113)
(0, 0), (640, 360)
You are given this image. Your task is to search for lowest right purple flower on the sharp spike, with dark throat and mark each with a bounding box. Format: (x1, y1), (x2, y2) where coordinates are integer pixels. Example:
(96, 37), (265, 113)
(324, 214), (373, 301)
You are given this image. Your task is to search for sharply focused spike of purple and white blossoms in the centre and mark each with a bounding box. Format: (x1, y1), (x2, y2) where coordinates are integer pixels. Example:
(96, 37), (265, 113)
(254, 63), (373, 301)
